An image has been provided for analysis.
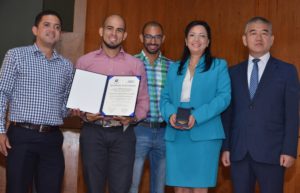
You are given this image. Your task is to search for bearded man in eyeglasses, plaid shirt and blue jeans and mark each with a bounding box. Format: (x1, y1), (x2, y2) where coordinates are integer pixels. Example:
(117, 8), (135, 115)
(130, 21), (172, 193)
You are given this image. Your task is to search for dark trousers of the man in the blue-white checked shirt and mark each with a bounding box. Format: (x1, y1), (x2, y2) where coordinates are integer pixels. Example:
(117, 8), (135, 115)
(6, 125), (65, 193)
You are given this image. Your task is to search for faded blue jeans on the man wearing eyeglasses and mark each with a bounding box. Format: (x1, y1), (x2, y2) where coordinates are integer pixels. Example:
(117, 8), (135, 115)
(129, 126), (166, 193)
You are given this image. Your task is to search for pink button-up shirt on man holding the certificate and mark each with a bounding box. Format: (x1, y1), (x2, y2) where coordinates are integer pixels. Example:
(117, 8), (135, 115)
(76, 49), (149, 120)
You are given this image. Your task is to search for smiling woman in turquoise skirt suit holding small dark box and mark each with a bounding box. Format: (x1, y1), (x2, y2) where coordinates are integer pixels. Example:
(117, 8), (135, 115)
(160, 21), (231, 193)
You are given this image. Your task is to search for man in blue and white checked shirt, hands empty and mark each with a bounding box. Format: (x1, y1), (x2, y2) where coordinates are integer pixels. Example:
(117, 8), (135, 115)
(0, 10), (73, 193)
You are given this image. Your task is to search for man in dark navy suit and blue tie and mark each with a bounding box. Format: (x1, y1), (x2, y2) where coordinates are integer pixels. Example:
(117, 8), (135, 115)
(222, 17), (299, 193)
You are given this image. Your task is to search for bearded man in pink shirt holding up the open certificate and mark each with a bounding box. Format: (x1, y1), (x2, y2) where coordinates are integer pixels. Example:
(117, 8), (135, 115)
(76, 15), (149, 193)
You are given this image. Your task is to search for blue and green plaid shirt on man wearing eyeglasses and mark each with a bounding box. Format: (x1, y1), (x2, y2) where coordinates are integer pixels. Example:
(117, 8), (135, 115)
(135, 51), (172, 122)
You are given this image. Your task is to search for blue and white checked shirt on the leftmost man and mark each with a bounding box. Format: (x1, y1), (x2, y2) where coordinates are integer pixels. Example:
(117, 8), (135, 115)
(0, 44), (74, 133)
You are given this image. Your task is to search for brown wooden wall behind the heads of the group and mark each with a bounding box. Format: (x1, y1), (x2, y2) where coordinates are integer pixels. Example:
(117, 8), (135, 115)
(85, 0), (300, 69)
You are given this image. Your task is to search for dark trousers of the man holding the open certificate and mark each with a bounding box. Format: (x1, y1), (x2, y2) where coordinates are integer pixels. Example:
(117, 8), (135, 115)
(80, 123), (136, 193)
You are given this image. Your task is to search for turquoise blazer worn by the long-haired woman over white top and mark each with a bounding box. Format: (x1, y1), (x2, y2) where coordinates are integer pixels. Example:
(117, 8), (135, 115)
(160, 57), (231, 141)
